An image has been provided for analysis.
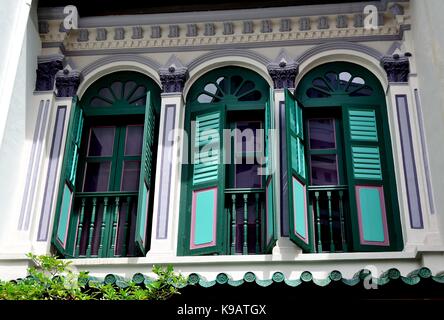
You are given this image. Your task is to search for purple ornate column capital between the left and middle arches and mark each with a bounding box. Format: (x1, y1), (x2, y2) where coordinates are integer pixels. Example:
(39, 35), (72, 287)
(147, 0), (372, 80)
(159, 55), (188, 93)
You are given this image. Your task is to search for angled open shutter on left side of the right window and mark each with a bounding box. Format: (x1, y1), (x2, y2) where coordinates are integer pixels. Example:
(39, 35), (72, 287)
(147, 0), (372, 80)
(284, 90), (314, 252)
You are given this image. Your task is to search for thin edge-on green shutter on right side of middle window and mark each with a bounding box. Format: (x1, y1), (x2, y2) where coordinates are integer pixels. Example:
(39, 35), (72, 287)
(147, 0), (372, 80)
(264, 89), (276, 253)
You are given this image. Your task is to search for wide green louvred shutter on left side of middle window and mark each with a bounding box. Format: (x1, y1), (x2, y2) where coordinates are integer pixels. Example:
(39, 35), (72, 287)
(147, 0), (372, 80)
(185, 108), (226, 255)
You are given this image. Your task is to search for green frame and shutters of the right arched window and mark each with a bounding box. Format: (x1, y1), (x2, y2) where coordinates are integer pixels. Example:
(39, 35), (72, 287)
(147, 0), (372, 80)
(284, 62), (403, 252)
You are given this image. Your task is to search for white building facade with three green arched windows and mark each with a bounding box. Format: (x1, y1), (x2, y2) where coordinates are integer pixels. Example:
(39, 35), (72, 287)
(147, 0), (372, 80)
(0, 0), (444, 284)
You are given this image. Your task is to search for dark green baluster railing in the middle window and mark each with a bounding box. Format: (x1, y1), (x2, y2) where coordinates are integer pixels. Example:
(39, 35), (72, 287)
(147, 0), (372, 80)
(225, 189), (265, 255)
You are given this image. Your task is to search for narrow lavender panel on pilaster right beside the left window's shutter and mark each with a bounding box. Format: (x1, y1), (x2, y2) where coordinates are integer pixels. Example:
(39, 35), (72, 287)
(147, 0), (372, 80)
(37, 106), (66, 241)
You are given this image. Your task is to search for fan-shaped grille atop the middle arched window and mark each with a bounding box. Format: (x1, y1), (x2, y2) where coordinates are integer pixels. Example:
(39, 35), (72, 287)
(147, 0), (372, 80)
(197, 75), (262, 103)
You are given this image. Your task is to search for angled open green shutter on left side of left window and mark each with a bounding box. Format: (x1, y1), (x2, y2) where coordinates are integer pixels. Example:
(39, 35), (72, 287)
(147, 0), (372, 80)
(52, 96), (84, 257)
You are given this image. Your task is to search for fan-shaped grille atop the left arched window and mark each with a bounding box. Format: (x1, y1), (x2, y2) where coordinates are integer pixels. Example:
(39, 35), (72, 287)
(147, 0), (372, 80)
(90, 80), (147, 107)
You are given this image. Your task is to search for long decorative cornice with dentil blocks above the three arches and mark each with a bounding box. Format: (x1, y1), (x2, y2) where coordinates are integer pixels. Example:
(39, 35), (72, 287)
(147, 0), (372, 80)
(40, 4), (410, 55)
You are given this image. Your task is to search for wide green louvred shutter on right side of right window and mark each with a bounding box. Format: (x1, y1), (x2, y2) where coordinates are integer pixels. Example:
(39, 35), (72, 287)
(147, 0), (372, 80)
(343, 106), (401, 251)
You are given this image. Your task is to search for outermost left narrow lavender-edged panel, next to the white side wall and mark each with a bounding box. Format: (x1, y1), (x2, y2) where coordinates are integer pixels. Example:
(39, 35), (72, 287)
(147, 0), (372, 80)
(18, 100), (49, 230)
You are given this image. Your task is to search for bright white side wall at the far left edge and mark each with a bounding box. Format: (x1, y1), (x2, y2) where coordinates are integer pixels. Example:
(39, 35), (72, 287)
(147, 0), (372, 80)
(0, 1), (41, 254)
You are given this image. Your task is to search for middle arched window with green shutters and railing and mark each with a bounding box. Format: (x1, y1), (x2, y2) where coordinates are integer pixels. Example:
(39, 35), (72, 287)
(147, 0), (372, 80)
(178, 67), (275, 255)
